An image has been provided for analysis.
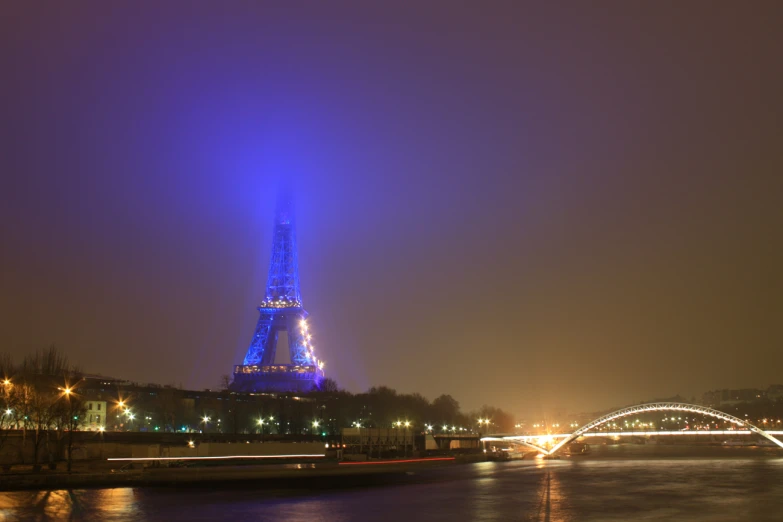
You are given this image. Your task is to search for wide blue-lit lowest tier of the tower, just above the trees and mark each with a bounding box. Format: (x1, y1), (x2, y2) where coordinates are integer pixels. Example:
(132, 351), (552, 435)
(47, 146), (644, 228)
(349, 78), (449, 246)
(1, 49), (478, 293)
(231, 364), (323, 393)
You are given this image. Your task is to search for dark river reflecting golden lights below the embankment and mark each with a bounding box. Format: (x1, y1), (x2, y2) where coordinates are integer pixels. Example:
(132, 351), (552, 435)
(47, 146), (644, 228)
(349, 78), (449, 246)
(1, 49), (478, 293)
(0, 447), (783, 522)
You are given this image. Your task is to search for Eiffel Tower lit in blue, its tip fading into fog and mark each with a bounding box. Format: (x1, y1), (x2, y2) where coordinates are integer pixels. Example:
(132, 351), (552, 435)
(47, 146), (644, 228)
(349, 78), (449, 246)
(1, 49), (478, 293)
(231, 190), (324, 392)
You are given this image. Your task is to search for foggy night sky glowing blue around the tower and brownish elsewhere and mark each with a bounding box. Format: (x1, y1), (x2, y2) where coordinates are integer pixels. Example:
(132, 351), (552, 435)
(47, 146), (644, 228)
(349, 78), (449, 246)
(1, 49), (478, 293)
(0, 1), (783, 416)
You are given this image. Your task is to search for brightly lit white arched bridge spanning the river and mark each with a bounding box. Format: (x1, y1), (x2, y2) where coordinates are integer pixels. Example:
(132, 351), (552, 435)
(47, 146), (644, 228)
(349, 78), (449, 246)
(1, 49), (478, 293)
(481, 402), (783, 455)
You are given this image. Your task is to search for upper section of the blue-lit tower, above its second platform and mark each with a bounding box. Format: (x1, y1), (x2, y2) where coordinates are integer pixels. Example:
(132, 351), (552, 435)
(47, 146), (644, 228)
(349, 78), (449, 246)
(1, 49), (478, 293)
(261, 186), (302, 308)
